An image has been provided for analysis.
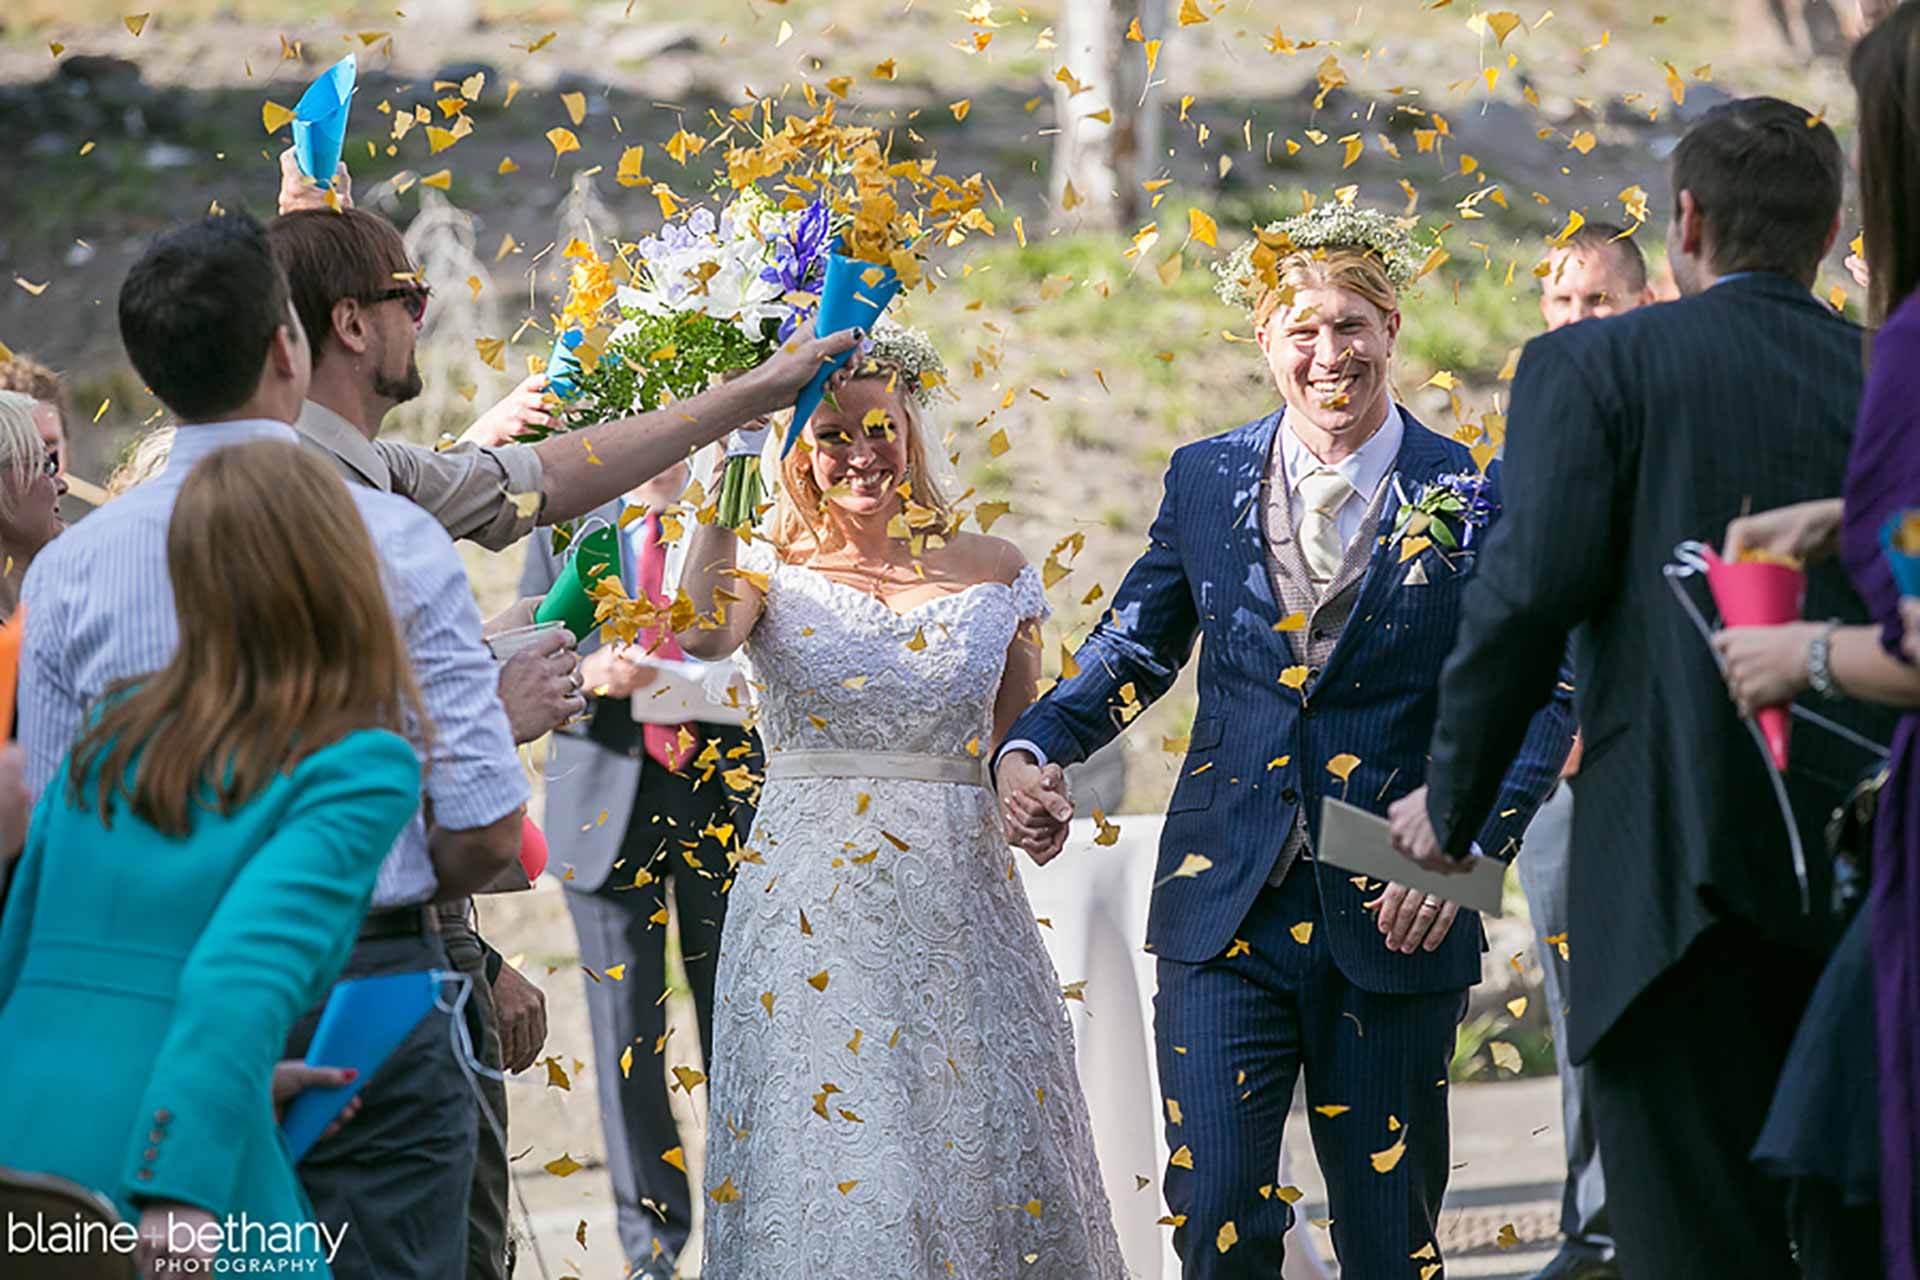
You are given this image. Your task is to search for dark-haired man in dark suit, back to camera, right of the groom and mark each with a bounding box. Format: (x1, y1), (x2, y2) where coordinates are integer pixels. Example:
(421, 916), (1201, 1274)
(1394, 98), (1885, 1280)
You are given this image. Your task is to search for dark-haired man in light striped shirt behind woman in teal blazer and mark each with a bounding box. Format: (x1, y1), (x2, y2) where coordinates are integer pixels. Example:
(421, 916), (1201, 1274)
(21, 215), (528, 1280)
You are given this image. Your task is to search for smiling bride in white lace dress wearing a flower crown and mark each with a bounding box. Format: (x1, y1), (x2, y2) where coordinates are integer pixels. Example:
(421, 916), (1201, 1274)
(678, 326), (1125, 1280)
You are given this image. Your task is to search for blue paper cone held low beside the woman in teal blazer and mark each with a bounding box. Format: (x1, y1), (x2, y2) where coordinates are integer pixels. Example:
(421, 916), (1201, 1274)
(280, 969), (436, 1165)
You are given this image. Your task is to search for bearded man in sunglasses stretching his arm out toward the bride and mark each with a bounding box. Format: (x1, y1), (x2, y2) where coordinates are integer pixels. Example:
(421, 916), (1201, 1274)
(269, 160), (854, 1280)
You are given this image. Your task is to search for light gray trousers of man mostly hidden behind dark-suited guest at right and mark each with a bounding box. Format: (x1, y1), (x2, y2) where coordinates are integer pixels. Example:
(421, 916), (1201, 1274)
(1519, 783), (1613, 1257)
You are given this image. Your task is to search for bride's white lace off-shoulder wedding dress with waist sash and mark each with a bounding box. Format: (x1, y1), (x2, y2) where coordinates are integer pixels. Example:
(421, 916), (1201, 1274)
(703, 543), (1127, 1280)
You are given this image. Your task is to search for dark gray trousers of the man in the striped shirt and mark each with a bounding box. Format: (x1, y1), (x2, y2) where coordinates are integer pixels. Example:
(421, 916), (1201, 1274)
(286, 935), (478, 1280)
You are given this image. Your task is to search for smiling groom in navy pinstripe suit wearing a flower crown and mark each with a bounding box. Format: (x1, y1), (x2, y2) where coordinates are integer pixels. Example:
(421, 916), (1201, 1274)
(996, 237), (1572, 1280)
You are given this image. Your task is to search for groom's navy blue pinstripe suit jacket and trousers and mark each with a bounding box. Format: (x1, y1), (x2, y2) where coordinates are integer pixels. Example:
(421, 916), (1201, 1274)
(1008, 411), (1572, 1280)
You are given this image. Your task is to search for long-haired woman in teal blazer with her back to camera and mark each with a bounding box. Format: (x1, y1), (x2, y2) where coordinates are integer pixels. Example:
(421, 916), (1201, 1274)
(0, 443), (422, 1276)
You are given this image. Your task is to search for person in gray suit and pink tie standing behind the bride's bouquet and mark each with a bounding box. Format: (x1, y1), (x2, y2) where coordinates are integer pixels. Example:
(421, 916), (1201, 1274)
(520, 462), (758, 1280)
